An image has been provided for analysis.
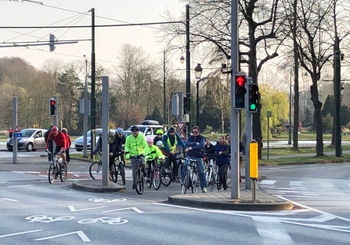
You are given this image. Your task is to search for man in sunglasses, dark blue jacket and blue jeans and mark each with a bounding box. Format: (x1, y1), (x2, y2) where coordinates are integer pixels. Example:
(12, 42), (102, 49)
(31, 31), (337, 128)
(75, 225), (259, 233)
(181, 126), (207, 192)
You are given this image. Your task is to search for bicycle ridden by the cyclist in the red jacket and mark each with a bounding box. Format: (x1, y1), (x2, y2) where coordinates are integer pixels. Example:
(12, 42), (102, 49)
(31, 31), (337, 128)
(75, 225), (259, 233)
(47, 151), (67, 184)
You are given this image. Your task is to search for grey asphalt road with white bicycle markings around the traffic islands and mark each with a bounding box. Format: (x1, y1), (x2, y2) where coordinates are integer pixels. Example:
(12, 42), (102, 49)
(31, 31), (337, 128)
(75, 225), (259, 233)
(0, 158), (350, 245)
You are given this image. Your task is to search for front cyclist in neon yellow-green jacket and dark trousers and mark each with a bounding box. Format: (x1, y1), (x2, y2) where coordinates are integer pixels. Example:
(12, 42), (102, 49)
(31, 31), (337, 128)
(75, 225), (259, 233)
(125, 125), (147, 190)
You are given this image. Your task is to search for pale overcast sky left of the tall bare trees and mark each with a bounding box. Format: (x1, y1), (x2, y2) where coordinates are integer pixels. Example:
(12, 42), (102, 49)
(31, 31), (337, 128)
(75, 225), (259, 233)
(0, 0), (185, 69)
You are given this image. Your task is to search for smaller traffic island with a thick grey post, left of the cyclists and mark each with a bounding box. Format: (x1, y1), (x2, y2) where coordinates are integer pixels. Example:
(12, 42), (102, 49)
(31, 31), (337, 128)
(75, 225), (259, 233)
(71, 179), (126, 193)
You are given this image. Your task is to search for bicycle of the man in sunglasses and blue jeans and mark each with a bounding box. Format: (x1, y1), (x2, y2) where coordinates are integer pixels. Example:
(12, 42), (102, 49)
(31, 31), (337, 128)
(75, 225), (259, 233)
(181, 158), (202, 194)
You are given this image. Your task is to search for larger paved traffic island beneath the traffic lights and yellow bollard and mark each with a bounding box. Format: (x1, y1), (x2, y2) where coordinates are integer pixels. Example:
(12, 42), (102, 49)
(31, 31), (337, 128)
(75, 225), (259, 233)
(168, 189), (294, 211)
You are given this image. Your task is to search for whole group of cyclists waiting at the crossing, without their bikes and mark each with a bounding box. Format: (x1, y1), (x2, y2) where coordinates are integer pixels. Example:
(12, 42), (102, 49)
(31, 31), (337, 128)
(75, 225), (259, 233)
(45, 125), (235, 192)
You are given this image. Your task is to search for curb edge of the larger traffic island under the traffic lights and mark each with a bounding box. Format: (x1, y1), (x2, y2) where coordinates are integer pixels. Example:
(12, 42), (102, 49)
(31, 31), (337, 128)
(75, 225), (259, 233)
(168, 196), (294, 211)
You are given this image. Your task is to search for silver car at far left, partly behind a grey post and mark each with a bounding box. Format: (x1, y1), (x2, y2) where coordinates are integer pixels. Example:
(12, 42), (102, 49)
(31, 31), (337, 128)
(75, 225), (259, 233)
(6, 128), (47, 151)
